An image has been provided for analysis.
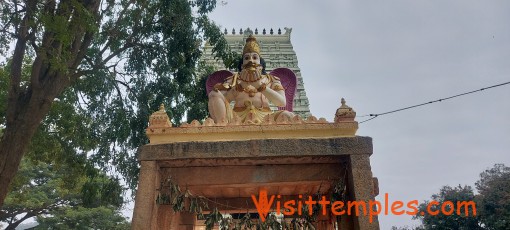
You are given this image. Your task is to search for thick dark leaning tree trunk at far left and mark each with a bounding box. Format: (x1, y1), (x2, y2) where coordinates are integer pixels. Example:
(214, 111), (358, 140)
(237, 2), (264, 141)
(0, 0), (100, 207)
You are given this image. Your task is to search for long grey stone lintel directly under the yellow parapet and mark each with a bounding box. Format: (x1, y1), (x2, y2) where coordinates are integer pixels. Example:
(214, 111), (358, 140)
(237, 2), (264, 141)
(138, 136), (373, 161)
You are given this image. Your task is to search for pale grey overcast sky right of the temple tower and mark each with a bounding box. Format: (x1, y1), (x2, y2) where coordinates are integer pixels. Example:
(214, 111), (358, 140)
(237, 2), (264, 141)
(211, 0), (510, 229)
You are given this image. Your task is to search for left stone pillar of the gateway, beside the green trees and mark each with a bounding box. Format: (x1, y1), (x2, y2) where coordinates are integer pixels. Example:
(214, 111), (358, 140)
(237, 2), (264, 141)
(131, 161), (159, 230)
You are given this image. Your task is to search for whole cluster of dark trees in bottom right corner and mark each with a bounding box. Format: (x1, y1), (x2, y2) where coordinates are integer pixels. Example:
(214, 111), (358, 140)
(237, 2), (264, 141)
(408, 164), (510, 230)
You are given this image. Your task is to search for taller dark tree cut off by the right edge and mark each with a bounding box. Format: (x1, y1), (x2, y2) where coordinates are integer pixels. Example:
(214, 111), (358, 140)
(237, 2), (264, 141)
(475, 164), (510, 230)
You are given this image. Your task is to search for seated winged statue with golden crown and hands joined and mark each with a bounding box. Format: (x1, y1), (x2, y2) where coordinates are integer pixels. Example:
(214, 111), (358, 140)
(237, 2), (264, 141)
(207, 35), (296, 124)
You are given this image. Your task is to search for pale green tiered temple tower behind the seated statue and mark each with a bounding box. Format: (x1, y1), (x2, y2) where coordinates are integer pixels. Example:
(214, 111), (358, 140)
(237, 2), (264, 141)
(202, 28), (311, 119)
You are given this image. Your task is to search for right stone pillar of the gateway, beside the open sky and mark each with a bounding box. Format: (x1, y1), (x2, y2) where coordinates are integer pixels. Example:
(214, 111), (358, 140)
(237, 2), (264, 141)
(348, 154), (379, 230)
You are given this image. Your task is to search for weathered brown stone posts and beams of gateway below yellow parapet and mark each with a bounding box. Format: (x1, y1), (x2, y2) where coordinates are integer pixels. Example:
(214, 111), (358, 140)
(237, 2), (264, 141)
(133, 136), (379, 230)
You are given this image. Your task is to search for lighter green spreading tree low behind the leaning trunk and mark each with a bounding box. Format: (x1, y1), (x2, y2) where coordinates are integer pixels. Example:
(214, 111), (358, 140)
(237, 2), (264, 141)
(0, 158), (128, 229)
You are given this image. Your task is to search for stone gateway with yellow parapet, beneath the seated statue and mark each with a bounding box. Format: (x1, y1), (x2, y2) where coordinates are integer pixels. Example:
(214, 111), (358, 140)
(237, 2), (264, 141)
(132, 100), (379, 230)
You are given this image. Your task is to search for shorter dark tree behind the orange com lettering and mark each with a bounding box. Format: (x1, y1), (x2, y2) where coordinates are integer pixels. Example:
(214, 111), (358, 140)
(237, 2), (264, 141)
(414, 185), (483, 230)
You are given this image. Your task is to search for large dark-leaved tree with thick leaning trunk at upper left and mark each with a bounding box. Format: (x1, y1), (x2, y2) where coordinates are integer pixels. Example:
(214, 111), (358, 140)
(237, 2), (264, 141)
(0, 0), (234, 206)
